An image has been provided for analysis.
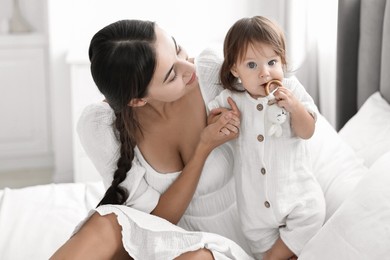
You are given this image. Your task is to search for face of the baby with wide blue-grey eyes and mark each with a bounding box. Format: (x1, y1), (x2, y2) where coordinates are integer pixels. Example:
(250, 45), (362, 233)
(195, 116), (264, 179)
(231, 42), (284, 98)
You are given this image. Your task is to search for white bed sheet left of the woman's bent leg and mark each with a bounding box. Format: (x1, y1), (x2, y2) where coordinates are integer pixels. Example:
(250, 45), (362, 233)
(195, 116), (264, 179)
(0, 182), (104, 260)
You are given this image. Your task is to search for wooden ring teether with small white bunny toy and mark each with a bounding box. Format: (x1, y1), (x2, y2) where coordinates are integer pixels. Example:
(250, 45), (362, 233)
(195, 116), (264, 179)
(265, 80), (287, 137)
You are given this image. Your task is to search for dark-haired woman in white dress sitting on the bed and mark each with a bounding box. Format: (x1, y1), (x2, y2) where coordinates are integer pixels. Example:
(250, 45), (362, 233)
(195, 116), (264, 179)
(52, 20), (250, 259)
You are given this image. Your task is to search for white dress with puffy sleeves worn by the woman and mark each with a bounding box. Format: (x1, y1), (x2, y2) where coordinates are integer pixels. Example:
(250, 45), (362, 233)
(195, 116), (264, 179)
(76, 50), (251, 259)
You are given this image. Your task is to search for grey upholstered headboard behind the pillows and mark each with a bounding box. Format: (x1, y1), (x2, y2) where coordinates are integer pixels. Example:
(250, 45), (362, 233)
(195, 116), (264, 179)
(336, 0), (390, 130)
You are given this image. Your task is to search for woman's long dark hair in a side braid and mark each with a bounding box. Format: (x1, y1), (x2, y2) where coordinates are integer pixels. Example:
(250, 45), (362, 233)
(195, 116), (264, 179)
(89, 20), (156, 206)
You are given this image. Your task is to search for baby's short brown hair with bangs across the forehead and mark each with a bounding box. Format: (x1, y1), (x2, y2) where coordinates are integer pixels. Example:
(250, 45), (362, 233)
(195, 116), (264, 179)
(220, 16), (287, 92)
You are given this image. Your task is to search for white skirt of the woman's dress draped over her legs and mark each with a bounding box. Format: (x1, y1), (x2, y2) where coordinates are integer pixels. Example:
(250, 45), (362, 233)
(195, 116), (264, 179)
(75, 205), (253, 260)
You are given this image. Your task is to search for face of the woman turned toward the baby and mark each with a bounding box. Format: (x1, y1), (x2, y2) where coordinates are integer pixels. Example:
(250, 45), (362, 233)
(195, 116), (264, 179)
(145, 26), (198, 103)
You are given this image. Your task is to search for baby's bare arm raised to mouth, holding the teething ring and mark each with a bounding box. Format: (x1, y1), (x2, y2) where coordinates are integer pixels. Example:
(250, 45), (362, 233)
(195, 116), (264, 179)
(274, 87), (315, 139)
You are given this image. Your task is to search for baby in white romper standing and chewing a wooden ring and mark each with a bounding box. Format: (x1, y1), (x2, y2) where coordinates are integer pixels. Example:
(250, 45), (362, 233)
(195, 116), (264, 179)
(208, 16), (325, 259)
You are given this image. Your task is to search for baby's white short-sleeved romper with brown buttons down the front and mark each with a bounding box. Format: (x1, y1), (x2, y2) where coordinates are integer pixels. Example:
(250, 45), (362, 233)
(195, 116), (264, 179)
(208, 77), (325, 259)
